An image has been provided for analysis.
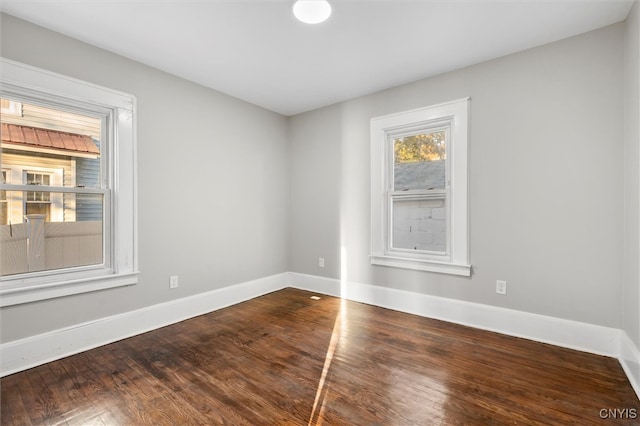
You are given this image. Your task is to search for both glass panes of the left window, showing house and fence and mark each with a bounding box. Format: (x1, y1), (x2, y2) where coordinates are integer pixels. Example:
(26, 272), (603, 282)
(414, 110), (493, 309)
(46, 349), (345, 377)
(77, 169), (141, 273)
(0, 98), (107, 276)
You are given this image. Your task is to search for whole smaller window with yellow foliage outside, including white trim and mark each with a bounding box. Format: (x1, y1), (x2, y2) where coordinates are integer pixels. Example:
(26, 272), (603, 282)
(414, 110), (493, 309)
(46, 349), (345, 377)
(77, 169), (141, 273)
(371, 98), (471, 276)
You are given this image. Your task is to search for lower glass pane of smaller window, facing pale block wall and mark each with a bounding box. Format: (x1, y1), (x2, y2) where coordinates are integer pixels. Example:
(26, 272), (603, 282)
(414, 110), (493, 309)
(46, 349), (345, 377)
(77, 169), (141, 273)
(392, 198), (447, 254)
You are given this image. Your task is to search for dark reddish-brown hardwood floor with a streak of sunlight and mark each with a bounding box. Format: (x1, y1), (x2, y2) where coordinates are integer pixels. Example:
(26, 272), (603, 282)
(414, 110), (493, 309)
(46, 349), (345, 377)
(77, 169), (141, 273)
(0, 289), (640, 426)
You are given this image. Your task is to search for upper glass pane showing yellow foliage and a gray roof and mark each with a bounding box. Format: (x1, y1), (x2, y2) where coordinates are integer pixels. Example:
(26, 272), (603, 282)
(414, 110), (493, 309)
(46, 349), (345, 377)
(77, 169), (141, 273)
(393, 130), (447, 191)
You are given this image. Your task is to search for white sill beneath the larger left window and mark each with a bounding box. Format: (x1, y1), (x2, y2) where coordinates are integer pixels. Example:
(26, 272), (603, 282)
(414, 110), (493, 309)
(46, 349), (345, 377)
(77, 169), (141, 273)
(0, 272), (138, 307)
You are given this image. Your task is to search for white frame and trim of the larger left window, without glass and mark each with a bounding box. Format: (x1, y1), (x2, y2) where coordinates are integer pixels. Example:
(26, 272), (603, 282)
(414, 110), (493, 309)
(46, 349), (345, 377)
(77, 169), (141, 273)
(0, 58), (139, 307)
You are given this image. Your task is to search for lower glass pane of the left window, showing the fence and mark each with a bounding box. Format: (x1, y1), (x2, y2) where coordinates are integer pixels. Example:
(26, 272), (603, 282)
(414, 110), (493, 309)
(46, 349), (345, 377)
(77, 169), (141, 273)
(0, 191), (104, 276)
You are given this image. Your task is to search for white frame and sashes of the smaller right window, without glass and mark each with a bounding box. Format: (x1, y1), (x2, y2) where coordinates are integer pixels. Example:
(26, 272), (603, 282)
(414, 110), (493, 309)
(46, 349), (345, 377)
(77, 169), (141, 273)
(370, 98), (471, 276)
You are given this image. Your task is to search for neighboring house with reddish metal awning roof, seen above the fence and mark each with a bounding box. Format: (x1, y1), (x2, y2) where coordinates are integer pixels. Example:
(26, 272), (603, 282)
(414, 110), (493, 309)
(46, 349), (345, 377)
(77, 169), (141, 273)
(0, 99), (102, 225)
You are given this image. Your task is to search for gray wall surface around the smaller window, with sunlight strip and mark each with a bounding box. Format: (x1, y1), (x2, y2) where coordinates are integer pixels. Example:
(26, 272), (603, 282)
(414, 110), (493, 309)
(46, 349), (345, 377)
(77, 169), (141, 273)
(291, 24), (625, 327)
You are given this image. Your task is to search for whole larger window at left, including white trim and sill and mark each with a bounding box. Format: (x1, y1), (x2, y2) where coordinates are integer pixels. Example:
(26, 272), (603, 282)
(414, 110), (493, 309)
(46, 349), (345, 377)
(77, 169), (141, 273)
(0, 59), (138, 306)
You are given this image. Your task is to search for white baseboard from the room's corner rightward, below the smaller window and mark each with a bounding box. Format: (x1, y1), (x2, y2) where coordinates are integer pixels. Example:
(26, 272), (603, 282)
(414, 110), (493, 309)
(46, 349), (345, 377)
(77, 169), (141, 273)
(289, 273), (640, 398)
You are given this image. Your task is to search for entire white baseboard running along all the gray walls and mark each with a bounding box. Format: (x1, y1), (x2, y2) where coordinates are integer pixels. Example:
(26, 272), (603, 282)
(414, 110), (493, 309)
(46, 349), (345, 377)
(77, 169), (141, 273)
(0, 272), (640, 398)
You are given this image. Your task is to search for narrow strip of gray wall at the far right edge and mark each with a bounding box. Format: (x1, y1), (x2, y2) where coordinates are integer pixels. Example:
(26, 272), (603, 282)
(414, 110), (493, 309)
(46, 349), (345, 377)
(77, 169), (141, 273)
(622, 2), (640, 350)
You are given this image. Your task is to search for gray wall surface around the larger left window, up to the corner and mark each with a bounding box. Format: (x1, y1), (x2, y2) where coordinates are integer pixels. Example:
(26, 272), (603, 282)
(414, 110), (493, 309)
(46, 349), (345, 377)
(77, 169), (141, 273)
(0, 15), (289, 342)
